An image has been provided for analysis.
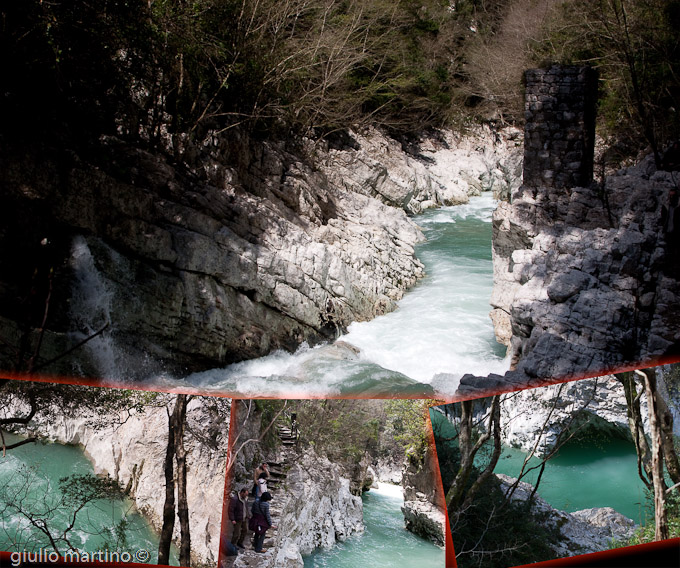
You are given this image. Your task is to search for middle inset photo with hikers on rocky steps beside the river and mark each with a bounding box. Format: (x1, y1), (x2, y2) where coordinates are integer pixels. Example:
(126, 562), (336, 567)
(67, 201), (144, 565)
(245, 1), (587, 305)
(222, 400), (445, 568)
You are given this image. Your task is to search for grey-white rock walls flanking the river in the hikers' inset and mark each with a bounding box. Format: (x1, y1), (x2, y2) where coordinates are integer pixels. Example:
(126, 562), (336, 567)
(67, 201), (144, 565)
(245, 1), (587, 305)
(225, 401), (445, 568)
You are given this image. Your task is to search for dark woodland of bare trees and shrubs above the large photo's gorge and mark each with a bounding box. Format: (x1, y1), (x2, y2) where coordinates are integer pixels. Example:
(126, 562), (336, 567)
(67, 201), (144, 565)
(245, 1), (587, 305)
(1, 0), (680, 155)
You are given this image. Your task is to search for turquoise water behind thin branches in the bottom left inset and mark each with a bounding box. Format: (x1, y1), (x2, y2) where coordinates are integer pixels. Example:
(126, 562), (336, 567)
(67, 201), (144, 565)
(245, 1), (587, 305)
(0, 433), (177, 564)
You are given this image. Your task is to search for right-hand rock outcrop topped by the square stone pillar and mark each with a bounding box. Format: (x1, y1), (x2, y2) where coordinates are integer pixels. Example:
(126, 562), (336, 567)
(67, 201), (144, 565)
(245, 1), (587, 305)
(459, 66), (680, 397)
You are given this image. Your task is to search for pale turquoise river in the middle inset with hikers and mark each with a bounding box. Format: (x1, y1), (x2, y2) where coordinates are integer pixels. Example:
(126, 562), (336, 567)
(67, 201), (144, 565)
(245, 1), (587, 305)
(304, 483), (444, 568)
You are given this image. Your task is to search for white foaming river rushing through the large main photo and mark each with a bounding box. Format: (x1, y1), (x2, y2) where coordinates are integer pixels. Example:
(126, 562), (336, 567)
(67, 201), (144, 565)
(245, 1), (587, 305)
(185, 194), (507, 397)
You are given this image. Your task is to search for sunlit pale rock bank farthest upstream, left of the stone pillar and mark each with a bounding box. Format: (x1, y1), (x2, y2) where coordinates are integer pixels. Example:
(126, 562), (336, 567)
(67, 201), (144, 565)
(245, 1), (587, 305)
(315, 128), (522, 214)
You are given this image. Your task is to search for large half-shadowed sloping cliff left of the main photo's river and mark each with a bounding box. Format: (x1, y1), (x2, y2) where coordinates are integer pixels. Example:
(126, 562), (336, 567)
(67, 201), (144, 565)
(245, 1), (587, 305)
(0, 137), (422, 377)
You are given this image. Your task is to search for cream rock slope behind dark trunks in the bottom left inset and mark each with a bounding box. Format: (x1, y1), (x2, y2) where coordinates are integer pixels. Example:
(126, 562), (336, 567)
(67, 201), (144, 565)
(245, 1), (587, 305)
(4, 397), (229, 566)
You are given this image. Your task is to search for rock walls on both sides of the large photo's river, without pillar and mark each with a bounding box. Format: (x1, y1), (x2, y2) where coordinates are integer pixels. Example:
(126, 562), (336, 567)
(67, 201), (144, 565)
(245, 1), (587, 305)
(7, 102), (678, 396)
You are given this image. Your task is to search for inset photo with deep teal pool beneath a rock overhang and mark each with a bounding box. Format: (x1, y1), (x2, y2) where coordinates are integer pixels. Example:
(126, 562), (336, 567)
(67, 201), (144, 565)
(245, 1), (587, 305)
(430, 365), (680, 568)
